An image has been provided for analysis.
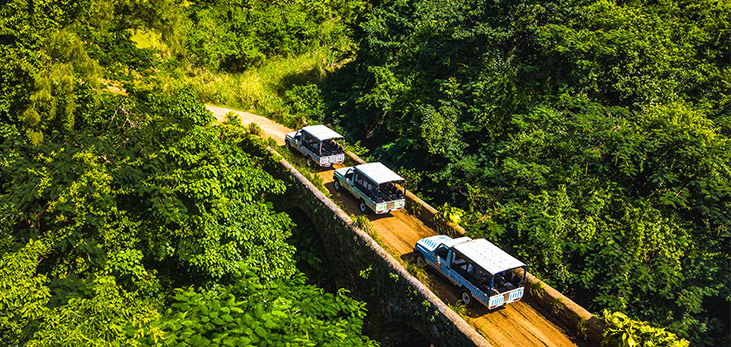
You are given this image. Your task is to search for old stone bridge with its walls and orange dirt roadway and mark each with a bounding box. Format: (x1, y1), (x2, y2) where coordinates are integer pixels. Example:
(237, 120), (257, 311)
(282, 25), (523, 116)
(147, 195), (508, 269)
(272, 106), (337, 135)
(206, 105), (603, 346)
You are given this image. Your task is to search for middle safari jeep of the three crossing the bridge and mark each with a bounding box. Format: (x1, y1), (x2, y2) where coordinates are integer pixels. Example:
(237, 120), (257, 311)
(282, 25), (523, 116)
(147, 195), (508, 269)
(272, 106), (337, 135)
(333, 163), (406, 214)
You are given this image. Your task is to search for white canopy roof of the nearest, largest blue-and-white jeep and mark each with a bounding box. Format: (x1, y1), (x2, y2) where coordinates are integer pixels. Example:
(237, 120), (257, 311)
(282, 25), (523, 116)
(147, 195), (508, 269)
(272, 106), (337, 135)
(454, 239), (525, 275)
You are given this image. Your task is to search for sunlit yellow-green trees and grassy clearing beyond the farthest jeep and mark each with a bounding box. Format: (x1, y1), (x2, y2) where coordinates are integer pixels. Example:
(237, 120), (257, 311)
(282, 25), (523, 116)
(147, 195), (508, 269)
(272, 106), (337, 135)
(121, 0), (365, 127)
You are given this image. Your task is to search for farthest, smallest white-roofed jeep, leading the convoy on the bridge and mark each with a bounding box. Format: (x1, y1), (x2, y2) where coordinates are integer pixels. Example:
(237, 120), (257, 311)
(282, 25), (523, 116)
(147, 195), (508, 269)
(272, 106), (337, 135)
(284, 125), (345, 167)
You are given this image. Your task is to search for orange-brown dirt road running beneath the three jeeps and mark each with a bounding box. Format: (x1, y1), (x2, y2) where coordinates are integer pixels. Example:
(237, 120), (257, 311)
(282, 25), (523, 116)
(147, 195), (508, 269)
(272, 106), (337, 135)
(207, 106), (576, 346)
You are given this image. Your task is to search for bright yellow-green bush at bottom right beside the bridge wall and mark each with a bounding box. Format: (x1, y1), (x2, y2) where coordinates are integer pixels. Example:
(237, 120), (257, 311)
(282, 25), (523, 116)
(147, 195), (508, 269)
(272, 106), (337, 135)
(602, 310), (690, 347)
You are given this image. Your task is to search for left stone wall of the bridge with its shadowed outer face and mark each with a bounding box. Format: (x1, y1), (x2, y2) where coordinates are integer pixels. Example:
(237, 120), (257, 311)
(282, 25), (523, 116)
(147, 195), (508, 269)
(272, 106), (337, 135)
(270, 151), (490, 346)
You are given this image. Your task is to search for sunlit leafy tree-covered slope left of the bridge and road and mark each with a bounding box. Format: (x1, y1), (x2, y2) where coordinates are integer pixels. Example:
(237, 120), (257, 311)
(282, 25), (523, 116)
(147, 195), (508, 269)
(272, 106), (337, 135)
(0, 0), (375, 346)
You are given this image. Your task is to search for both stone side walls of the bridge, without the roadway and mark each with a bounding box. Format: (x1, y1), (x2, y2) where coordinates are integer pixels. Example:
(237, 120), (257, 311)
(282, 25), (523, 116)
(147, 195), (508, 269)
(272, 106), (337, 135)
(269, 148), (603, 346)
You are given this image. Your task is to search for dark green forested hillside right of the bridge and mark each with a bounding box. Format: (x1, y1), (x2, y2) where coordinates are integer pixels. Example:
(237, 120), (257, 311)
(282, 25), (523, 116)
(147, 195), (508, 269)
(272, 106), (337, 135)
(318, 0), (731, 345)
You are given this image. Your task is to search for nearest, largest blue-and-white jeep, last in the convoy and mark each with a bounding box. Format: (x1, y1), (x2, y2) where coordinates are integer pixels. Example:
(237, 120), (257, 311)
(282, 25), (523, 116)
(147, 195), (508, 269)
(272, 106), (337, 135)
(414, 235), (527, 310)
